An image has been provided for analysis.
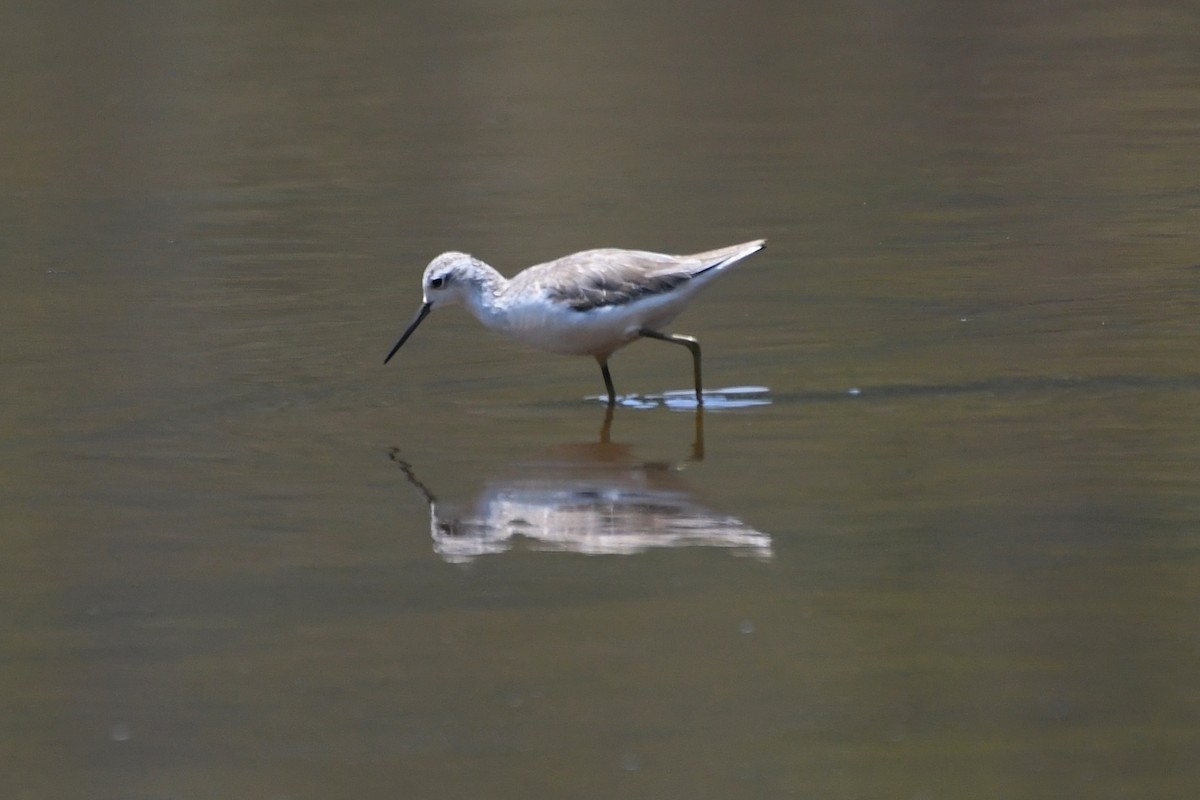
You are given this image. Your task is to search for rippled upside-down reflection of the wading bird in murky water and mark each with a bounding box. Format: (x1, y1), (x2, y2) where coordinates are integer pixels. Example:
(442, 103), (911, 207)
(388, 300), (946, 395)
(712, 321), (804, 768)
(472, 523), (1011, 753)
(391, 408), (773, 564)
